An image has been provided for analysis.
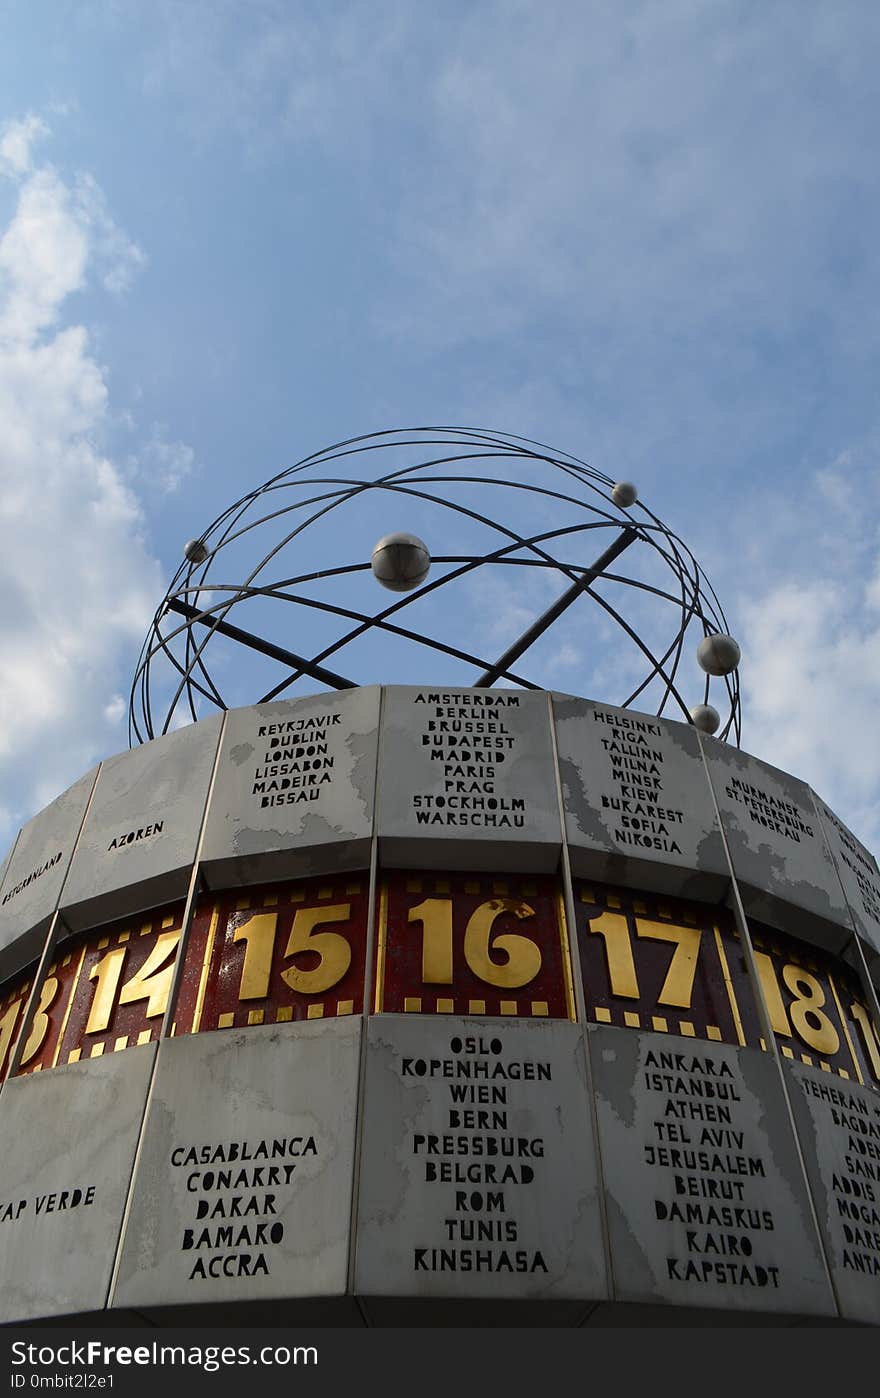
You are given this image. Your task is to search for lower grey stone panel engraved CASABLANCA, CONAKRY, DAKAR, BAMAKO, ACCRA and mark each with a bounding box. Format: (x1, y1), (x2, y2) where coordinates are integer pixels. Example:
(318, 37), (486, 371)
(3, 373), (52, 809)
(113, 1019), (362, 1309)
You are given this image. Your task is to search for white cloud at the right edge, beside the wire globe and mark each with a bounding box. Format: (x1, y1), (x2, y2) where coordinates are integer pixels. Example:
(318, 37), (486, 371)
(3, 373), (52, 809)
(737, 445), (880, 853)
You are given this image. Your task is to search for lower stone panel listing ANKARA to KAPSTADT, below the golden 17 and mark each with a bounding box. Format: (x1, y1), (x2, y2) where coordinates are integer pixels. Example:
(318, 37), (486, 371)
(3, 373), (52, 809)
(588, 1028), (837, 1316)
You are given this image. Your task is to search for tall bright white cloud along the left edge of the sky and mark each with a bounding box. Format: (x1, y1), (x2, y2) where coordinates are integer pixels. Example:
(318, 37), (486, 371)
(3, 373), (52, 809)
(0, 117), (165, 839)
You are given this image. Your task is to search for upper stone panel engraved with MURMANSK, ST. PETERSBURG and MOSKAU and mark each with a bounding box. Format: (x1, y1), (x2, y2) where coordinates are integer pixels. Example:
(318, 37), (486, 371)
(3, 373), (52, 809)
(704, 738), (852, 951)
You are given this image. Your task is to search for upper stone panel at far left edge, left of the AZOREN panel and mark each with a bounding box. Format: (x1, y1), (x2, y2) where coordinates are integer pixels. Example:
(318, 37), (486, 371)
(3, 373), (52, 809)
(0, 768), (98, 974)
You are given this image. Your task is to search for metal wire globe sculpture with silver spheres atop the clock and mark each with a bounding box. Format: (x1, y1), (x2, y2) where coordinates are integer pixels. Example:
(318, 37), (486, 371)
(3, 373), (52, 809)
(129, 426), (740, 745)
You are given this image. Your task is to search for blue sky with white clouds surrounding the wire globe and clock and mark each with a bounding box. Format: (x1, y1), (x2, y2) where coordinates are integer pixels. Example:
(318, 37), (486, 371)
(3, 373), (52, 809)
(0, 0), (880, 850)
